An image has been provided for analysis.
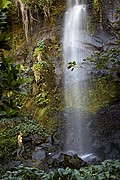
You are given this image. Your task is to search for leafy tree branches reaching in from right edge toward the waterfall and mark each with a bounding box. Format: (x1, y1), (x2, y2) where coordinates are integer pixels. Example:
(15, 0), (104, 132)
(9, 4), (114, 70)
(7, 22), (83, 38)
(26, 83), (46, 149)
(83, 41), (120, 81)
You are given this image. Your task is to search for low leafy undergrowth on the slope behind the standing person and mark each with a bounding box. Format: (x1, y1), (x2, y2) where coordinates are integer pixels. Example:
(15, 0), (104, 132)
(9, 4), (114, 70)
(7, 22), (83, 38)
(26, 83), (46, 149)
(0, 118), (48, 160)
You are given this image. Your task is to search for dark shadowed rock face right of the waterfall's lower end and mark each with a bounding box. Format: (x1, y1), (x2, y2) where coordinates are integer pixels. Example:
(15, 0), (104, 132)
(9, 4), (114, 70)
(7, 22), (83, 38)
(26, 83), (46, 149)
(90, 102), (120, 159)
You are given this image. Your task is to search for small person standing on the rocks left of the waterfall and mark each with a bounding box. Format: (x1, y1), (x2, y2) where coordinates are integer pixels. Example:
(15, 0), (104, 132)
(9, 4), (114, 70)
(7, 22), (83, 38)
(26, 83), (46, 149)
(17, 131), (24, 157)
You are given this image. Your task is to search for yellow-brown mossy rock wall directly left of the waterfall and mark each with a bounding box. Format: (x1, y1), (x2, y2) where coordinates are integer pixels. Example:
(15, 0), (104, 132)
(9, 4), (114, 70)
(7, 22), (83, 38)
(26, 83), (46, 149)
(6, 1), (65, 124)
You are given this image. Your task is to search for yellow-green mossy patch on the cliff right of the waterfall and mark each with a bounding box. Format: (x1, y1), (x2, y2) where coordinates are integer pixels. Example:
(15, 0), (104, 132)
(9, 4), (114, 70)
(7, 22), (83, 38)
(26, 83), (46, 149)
(86, 77), (117, 113)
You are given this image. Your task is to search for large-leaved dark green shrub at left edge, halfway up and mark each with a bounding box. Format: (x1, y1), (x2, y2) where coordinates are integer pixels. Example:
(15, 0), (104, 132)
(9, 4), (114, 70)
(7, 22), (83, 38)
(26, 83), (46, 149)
(0, 53), (28, 117)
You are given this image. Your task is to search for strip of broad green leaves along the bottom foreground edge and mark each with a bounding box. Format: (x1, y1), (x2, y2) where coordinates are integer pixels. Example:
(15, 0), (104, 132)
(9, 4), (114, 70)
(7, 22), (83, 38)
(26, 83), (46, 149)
(2, 160), (120, 180)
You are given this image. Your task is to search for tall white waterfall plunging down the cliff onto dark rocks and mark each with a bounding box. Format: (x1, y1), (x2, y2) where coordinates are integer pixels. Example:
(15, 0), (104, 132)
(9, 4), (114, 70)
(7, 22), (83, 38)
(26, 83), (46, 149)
(63, 2), (92, 160)
